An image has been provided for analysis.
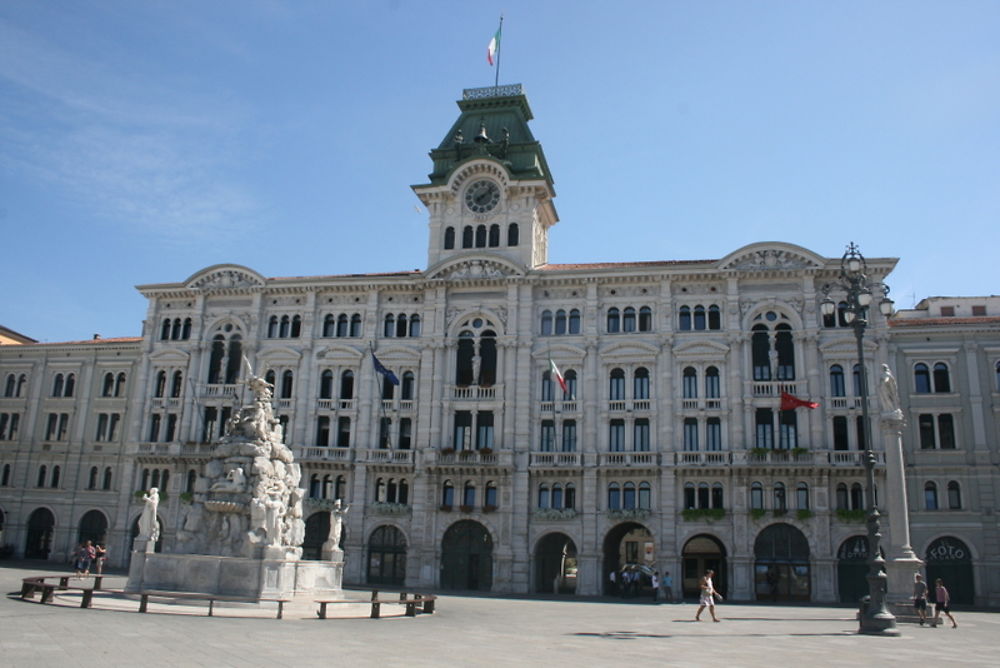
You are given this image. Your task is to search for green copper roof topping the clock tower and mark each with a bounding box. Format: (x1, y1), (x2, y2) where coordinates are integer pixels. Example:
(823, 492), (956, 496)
(418, 84), (552, 185)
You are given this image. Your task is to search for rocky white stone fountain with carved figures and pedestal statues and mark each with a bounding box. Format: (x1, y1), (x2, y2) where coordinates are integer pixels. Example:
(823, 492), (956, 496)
(127, 358), (343, 599)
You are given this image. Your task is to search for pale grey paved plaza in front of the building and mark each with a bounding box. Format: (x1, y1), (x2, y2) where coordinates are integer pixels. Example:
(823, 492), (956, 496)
(0, 563), (1000, 668)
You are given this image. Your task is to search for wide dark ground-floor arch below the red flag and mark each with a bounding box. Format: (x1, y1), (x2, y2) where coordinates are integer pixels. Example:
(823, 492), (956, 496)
(753, 523), (811, 602)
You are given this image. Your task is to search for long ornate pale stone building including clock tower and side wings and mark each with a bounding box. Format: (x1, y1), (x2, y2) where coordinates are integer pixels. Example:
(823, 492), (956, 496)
(0, 86), (1000, 606)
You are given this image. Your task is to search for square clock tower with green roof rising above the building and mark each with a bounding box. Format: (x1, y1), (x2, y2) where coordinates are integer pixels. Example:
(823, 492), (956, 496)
(413, 84), (559, 275)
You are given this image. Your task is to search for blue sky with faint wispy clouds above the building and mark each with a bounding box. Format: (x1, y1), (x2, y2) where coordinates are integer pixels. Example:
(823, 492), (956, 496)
(0, 0), (1000, 341)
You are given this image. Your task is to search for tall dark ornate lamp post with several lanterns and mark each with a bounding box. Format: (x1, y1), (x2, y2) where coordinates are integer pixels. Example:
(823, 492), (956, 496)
(820, 241), (905, 635)
